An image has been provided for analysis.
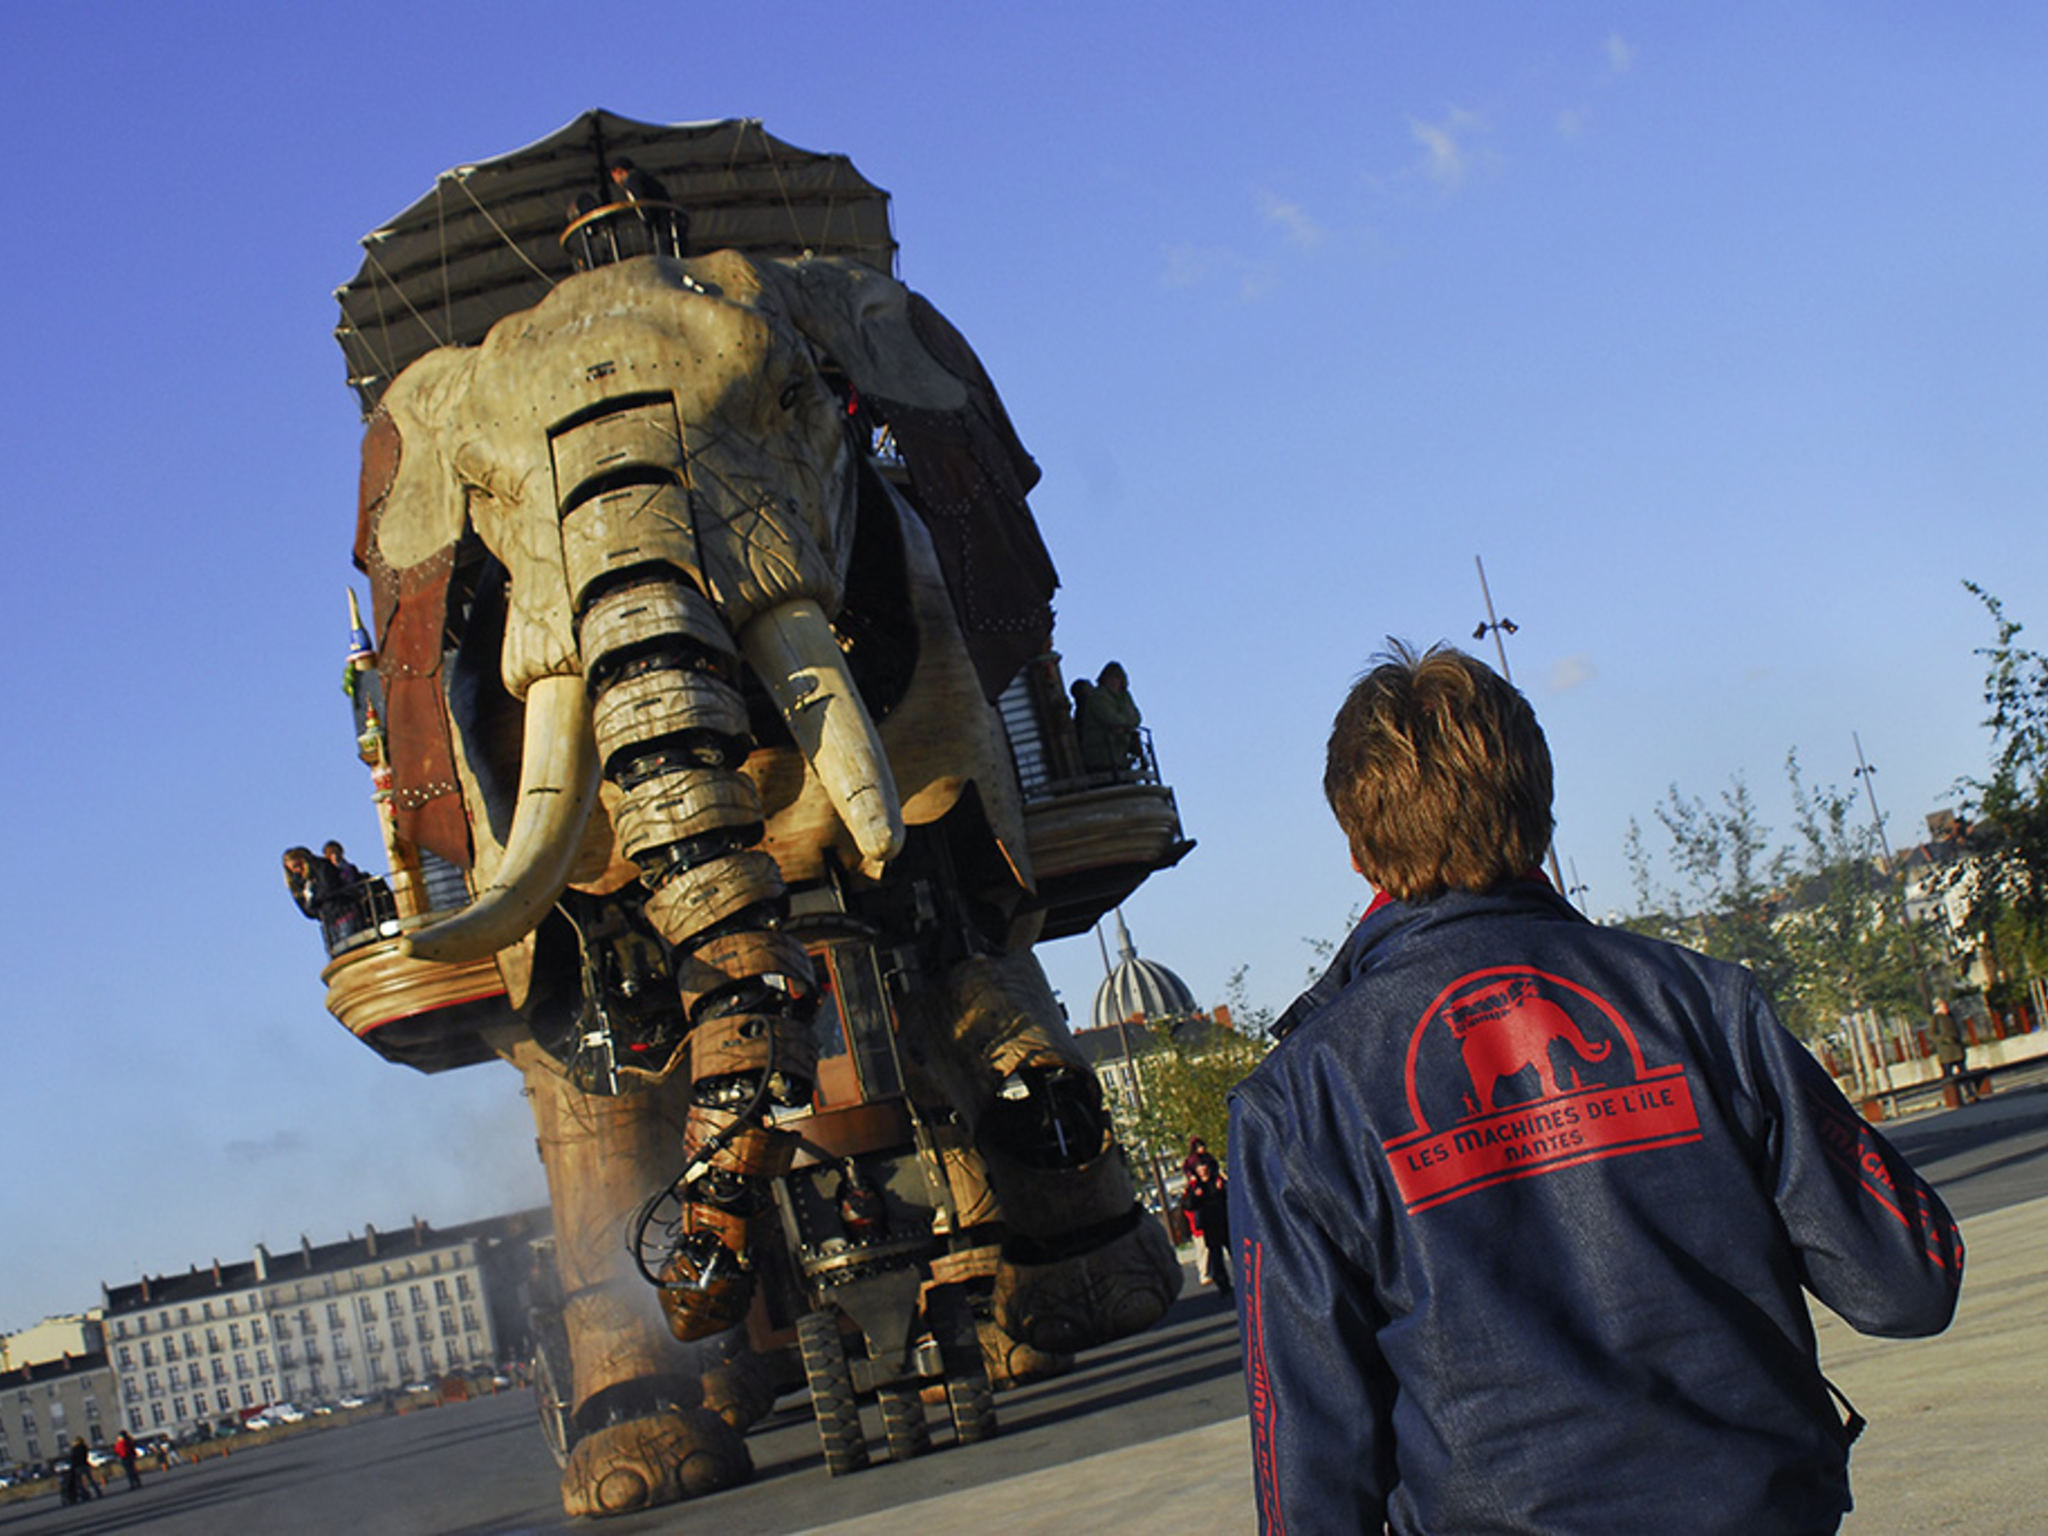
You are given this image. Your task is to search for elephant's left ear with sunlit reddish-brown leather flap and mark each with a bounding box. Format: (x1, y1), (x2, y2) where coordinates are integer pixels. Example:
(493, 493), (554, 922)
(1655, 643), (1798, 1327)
(356, 354), (475, 868)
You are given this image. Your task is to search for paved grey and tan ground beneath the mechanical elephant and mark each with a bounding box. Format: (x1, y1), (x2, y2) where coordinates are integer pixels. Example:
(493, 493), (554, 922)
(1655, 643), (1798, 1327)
(0, 1083), (2048, 1536)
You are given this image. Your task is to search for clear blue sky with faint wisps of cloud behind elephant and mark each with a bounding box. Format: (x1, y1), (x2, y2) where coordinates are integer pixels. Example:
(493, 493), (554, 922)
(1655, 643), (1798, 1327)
(0, 0), (2048, 1327)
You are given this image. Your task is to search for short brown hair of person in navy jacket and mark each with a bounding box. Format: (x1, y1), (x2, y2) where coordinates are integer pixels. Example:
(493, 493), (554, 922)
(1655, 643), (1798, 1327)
(1323, 639), (1552, 901)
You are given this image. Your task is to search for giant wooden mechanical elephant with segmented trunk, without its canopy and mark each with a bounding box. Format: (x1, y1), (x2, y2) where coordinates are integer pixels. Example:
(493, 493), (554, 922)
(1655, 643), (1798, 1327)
(328, 252), (1184, 1513)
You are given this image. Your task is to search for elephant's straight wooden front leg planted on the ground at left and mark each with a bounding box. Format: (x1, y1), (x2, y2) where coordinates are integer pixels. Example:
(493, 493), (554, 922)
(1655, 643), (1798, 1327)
(520, 1047), (754, 1516)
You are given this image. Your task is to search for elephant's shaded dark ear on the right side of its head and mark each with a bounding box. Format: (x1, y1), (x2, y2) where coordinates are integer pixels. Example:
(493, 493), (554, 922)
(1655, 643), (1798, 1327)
(764, 258), (1059, 698)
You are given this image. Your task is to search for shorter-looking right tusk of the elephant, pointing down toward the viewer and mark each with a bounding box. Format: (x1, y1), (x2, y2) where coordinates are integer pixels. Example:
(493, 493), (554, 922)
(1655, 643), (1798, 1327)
(739, 598), (903, 874)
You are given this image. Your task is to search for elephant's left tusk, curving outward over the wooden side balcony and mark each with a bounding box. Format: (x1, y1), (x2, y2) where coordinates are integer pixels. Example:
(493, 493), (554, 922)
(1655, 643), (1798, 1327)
(406, 676), (598, 961)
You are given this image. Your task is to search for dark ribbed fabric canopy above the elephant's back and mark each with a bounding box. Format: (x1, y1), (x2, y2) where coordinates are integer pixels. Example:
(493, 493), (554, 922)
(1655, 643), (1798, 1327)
(334, 111), (897, 418)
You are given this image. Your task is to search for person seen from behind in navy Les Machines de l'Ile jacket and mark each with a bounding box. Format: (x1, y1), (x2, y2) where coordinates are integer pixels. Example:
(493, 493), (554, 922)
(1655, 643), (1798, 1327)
(1229, 645), (1962, 1536)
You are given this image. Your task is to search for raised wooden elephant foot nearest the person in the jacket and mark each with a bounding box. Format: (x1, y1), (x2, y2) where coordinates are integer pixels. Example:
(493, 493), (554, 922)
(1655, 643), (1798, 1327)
(995, 1206), (1182, 1354)
